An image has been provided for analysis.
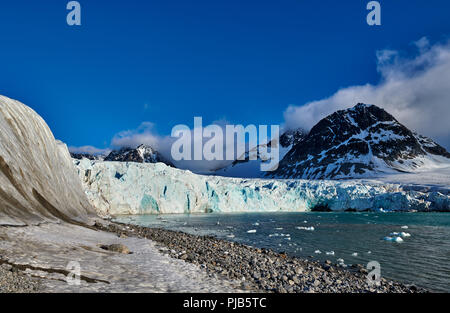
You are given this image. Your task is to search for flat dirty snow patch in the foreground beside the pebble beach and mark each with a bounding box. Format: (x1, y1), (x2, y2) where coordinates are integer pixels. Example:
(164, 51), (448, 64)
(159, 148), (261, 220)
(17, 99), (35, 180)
(0, 224), (242, 293)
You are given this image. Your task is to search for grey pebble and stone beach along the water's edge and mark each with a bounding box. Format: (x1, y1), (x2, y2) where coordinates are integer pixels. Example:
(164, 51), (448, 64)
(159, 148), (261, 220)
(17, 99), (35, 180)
(95, 222), (427, 293)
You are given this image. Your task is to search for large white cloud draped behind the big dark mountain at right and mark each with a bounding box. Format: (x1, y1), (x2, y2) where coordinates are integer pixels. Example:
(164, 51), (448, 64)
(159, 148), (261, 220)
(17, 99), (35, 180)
(284, 38), (450, 148)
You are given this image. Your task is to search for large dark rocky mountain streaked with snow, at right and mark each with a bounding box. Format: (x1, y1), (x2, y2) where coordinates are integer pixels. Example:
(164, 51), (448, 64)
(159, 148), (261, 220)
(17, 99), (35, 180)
(268, 104), (450, 179)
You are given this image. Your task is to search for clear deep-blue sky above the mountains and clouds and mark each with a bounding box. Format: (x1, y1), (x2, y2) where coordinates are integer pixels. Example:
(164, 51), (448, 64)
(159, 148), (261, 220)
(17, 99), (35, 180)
(0, 0), (450, 152)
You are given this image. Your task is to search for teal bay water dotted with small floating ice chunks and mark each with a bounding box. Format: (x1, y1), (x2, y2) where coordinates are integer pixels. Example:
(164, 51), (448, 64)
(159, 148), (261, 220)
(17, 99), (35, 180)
(117, 213), (450, 292)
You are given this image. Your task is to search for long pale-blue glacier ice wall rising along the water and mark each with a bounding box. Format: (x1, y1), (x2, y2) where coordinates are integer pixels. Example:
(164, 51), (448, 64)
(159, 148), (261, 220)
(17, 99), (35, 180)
(73, 159), (450, 215)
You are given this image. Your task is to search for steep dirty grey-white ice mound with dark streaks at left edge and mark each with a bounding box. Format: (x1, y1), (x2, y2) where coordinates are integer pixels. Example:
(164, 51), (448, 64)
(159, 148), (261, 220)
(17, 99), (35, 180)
(0, 96), (95, 225)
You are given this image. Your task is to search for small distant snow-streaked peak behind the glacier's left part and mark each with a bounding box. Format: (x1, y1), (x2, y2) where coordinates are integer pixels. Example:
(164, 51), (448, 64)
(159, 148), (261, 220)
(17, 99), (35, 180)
(104, 145), (175, 167)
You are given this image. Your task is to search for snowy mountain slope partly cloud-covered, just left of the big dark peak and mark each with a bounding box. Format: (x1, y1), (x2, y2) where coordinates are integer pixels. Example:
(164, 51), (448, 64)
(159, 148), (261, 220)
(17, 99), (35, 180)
(213, 128), (306, 178)
